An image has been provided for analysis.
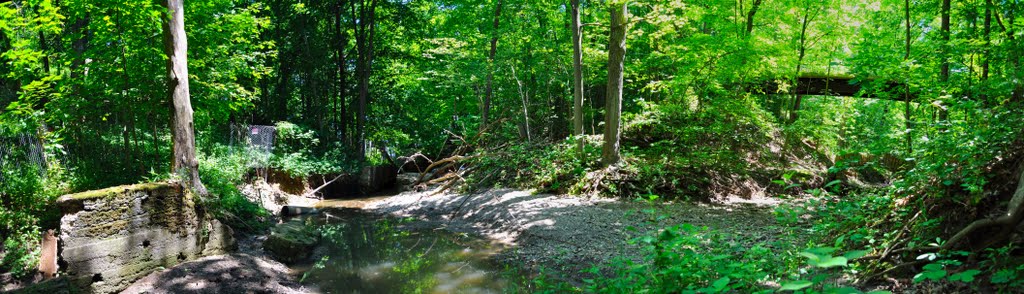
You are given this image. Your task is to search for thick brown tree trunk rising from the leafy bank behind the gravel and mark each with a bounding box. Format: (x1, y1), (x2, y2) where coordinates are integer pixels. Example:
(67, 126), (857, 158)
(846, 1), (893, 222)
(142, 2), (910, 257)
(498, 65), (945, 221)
(601, 1), (628, 166)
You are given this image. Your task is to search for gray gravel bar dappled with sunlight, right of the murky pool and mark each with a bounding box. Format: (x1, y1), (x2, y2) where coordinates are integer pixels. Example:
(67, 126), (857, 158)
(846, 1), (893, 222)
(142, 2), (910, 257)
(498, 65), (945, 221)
(366, 190), (786, 282)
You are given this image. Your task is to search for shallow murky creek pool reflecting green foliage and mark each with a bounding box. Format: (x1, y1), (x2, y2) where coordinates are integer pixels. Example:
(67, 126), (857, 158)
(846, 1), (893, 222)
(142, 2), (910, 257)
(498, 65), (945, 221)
(294, 199), (515, 293)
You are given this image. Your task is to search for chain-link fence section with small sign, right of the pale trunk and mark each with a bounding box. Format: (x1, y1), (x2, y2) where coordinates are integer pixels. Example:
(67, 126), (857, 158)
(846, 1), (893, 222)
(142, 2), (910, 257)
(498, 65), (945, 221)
(228, 125), (278, 178)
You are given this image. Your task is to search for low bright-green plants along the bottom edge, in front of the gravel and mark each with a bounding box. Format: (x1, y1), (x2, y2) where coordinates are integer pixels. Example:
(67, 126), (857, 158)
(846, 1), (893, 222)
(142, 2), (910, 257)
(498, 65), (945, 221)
(534, 197), (888, 293)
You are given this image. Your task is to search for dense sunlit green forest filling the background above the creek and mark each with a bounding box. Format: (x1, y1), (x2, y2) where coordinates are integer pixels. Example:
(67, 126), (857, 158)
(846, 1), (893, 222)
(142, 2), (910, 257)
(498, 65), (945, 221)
(0, 0), (1024, 292)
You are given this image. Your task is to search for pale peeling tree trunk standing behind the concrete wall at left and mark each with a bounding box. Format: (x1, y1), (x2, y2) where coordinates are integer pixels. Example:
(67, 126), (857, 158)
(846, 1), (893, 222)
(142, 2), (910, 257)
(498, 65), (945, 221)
(163, 0), (207, 195)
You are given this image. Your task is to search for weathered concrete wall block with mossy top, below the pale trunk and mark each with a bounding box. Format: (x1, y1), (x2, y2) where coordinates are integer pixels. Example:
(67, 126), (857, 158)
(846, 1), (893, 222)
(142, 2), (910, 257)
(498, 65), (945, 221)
(57, 182), (234, 293)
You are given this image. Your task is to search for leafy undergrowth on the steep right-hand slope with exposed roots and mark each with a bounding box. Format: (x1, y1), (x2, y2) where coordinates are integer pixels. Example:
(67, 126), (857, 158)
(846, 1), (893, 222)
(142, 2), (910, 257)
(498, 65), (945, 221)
(775, 105), (1024, 292)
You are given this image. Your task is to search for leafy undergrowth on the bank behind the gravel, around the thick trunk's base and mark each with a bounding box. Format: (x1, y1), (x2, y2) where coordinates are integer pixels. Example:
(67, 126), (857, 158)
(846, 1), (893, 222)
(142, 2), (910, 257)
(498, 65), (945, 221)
(469, 97), (783, 200)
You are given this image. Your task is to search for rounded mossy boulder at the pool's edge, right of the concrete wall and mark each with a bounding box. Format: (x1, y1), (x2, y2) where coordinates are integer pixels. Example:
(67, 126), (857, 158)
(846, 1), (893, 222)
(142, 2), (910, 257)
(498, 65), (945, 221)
(263, 219), (319, 263)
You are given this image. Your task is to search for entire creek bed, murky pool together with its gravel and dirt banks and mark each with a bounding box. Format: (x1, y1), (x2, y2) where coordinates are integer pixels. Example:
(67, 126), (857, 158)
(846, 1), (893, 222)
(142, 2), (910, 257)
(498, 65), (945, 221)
(119, 184), (784, 293)
